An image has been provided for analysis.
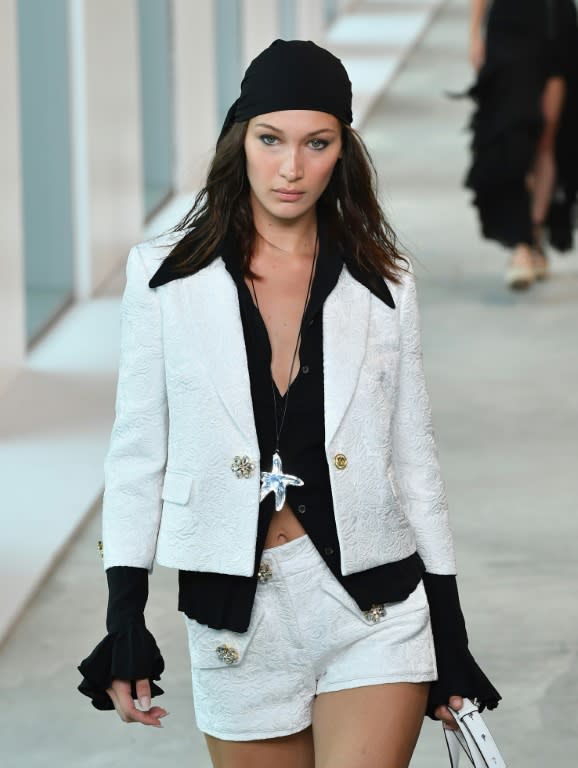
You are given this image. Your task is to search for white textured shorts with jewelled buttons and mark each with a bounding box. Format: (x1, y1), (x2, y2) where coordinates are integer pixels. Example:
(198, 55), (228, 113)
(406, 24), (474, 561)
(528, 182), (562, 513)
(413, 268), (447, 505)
(185, 536), (436, 741)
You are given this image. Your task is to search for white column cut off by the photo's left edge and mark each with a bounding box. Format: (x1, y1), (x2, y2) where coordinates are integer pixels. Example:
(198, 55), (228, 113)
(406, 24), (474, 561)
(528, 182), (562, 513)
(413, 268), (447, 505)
(0, 0), (26, 378)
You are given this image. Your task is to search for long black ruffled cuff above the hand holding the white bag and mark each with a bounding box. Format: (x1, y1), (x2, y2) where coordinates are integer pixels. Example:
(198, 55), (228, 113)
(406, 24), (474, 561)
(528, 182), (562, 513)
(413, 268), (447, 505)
(423, 573), (502, 720)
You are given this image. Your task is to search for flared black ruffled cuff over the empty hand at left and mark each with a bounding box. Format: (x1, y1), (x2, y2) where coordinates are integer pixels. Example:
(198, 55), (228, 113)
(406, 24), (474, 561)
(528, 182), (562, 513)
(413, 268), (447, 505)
(78, 623), (165, 710)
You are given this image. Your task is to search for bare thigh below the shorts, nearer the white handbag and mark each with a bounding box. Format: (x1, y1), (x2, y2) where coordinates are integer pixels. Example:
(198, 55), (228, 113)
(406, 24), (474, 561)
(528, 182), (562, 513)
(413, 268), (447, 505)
(313, 683), (429, 768)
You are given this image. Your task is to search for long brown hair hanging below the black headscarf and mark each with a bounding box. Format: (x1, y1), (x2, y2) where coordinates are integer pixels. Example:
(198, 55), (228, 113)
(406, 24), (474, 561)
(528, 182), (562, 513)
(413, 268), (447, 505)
(160, 122), (408, 283)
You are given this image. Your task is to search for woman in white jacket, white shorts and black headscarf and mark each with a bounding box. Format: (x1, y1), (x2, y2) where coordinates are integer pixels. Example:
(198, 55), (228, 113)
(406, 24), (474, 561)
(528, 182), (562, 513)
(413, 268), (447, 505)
(80, 40), (500, 768)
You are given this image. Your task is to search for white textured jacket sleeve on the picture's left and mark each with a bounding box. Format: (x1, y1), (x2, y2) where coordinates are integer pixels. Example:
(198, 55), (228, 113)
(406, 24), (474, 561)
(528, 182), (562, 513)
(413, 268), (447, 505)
(103, 246), (168, 571)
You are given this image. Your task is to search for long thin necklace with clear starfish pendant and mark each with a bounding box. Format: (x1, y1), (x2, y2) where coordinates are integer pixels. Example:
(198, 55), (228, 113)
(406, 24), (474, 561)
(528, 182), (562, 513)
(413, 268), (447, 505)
(251, 233), (319, 512)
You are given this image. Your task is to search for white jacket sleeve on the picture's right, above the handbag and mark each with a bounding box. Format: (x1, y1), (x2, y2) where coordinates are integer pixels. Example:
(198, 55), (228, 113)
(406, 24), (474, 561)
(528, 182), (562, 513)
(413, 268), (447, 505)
(392, 273), (456, 574)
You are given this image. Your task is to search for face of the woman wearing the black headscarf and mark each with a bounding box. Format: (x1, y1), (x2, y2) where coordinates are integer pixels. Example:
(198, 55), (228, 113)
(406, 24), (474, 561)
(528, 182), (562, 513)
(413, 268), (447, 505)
(245, 109), (342, 221)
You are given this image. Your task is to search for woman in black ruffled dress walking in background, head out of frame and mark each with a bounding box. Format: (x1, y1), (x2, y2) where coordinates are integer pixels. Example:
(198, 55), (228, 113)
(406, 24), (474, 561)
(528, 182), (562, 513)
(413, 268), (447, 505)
(466, 0), (578, 289)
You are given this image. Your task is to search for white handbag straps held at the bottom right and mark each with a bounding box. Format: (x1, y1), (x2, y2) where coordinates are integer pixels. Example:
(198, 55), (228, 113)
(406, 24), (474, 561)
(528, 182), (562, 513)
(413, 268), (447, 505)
(444, 699), (506, 768)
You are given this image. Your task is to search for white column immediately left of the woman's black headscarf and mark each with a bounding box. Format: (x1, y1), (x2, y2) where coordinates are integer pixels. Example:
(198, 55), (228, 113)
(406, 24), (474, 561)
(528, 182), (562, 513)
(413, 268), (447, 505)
(173, 0), (218, 193)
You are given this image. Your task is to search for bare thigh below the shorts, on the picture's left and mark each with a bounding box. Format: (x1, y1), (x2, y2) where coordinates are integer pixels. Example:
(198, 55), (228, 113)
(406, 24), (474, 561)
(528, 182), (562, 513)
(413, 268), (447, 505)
(205, 728), (315, 768)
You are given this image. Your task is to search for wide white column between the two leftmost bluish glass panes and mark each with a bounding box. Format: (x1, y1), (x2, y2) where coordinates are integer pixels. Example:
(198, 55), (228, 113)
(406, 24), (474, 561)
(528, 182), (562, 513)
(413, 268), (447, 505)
(84, 0), (144, 292)
